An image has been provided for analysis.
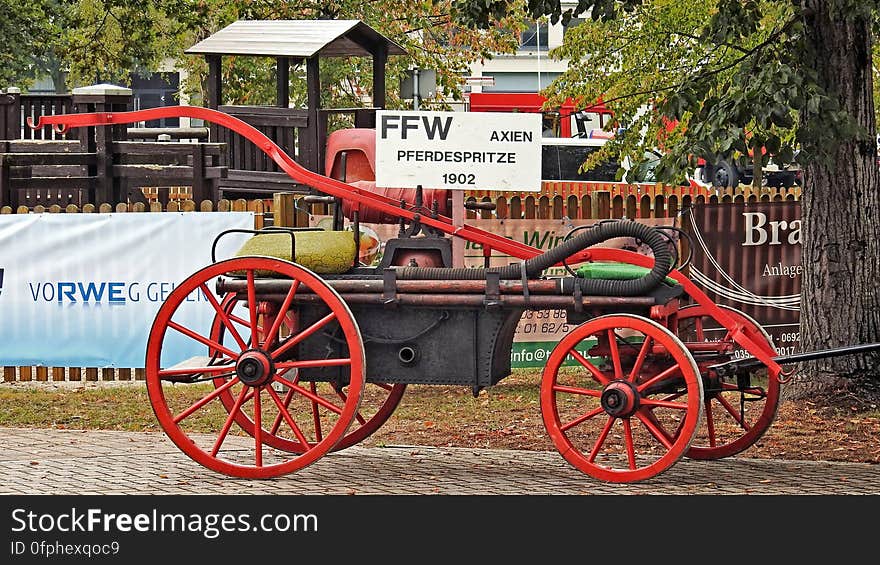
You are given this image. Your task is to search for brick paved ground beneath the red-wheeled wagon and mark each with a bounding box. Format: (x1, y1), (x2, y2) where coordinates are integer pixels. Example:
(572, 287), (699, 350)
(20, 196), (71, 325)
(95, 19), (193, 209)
(0, 428), (880, 495)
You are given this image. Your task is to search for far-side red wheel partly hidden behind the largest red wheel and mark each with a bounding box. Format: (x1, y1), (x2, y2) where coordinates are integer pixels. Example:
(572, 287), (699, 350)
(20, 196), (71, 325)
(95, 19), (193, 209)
(209, 293), (406, 453)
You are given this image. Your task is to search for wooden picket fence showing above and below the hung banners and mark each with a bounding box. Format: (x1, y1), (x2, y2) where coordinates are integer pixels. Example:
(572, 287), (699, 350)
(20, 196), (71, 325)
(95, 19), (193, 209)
(0, 185), (800, 382)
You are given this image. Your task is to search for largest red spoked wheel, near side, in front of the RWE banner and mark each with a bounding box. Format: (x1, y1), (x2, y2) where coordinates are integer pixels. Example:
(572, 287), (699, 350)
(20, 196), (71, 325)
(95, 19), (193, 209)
(146, 257), (364, 478)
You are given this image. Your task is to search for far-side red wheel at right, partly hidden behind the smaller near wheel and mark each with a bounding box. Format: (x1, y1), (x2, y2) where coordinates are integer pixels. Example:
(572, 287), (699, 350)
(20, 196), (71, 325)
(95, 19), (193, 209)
(678, 304), (780, 459)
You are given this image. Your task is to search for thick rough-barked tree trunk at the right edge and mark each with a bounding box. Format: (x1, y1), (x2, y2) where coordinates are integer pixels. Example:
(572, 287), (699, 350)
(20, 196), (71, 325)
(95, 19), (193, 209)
(785, 0), (880, 406)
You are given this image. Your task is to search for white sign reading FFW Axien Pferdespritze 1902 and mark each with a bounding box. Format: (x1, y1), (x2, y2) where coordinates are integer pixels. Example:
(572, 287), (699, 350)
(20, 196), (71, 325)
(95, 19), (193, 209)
(376, 110), (541, 192)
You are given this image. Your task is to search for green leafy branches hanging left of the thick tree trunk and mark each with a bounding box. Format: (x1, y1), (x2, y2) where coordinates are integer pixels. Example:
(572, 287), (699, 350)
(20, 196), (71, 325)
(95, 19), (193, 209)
(454, 0), (880, 182)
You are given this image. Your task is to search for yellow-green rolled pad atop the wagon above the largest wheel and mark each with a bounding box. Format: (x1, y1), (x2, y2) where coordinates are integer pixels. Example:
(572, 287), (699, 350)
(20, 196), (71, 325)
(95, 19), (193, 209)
(235, 230), (355, 275)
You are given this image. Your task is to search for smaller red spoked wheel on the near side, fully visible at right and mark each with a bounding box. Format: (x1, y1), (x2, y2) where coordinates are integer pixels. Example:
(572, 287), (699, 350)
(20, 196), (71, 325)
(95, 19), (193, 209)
(541, 314), (703, 482)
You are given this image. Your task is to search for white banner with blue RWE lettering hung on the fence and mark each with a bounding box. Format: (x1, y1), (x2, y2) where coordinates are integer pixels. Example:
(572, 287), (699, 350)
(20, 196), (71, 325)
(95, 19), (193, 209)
(0, 212), (254, 367)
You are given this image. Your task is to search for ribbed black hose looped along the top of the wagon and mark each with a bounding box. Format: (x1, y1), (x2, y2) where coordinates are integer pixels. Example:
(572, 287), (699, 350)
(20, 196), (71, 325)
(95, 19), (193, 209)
(396, 220), (673, 296)
